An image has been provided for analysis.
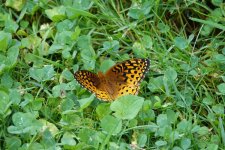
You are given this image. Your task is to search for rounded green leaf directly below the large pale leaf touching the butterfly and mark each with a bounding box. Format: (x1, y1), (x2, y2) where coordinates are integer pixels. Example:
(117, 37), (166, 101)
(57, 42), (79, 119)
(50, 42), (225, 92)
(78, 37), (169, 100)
(101, 115), (122, 135)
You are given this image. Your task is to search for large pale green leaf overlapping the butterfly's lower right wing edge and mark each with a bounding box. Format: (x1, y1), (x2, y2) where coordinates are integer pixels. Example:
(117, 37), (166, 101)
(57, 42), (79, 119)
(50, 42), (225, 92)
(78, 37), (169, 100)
(110, 95), (144, 120)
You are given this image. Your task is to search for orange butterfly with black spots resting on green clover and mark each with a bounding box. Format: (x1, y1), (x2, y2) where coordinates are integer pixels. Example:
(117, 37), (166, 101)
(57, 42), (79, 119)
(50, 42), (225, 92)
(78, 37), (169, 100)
(74, 58), (150, 101)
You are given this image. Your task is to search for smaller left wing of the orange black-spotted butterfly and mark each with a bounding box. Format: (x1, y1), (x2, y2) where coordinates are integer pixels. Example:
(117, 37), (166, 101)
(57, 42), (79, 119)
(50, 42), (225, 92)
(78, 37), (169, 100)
(74, 70), (111, 101)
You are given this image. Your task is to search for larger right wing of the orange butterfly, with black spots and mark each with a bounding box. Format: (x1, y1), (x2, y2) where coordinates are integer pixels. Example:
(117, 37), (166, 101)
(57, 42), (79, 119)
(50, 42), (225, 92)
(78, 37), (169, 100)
(105, 59), (150, 98)
